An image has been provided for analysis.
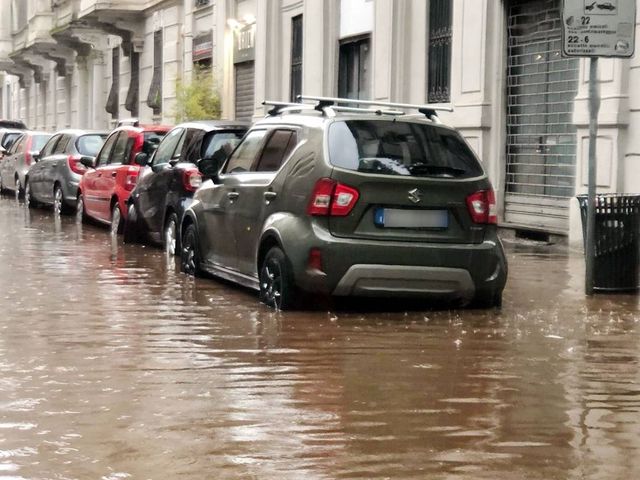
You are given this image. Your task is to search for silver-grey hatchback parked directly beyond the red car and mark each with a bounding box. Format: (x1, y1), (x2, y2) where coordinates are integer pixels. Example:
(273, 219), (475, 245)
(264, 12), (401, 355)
(25, 130), (108, 214)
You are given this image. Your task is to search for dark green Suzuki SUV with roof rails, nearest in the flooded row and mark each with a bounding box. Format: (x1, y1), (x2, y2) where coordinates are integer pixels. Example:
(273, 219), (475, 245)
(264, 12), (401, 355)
(181, 97), (507, 310)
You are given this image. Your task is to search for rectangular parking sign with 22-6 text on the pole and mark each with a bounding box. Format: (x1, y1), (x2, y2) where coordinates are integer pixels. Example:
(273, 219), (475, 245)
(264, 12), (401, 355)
(562, 0), (636, 57)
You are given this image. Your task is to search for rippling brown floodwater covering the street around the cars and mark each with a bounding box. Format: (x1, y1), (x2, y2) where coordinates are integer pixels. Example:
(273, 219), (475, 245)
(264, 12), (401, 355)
(0, 193), (640, 480)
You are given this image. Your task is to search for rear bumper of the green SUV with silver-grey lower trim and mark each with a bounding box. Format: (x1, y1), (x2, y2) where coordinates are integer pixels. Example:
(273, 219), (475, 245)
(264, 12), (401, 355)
(284, 224), (507, 300)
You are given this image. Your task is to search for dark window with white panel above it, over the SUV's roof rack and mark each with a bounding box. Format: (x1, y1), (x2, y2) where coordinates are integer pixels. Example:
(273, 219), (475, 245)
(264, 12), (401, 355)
(338, 36), (371, 99)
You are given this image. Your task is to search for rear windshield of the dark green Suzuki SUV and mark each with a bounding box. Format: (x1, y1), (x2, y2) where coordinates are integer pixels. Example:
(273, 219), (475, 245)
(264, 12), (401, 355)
(329, 120), (483, 178)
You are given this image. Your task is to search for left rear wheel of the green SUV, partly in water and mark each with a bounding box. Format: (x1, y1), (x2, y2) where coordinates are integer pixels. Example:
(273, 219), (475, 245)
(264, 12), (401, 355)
(259, 247), (299, 310)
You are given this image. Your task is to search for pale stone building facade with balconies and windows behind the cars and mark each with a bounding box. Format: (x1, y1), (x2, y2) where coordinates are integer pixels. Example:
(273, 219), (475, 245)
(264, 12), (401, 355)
(0, 0), (640, 245)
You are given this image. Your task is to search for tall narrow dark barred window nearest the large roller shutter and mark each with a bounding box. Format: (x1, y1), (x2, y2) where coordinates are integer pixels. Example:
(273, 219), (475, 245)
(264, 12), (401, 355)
(427, 0), (452, 103)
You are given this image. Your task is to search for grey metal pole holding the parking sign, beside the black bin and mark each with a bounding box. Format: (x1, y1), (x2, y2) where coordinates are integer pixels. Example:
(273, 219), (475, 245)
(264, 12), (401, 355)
(584, 57), (600, 295)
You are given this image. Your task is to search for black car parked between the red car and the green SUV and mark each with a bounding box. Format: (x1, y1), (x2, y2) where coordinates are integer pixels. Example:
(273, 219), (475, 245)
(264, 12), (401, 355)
(124, 120), (248, 254)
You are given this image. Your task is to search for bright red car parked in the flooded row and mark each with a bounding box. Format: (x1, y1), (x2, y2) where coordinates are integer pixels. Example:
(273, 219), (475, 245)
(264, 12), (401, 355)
(77, 124), (171, 234)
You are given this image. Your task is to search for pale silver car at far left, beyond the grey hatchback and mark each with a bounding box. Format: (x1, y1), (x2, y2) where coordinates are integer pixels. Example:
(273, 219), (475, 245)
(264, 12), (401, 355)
(0, 130), (51, 195)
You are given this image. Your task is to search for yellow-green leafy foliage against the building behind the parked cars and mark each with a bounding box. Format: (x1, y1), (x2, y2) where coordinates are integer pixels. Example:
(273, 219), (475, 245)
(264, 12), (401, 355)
(175, 68), (222, 123)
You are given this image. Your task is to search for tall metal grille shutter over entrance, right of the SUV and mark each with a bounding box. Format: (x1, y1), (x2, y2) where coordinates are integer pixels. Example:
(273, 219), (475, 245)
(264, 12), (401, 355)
(505, 0), (579, 234)
